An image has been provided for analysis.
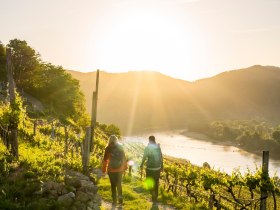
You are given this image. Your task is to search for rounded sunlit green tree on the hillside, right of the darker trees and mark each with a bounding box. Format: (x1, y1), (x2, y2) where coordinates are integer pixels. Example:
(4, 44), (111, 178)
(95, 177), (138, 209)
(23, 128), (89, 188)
(29, 63), (86, 123)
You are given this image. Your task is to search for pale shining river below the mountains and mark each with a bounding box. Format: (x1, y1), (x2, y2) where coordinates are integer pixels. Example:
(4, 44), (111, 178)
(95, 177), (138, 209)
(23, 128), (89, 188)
(123, 132), (280, 177)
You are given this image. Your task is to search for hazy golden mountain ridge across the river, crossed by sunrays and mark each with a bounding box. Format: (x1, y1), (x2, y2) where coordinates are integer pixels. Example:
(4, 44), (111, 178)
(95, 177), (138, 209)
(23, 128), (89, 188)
(69, 66), (280, 134)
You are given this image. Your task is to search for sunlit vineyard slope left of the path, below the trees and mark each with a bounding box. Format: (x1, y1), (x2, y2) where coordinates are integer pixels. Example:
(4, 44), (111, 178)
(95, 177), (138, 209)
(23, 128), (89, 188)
(0, 101), (114, 210)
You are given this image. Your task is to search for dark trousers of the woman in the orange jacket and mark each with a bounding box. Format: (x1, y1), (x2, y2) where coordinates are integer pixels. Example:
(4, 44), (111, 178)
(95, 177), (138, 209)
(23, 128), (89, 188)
(108, 172), (123, 203)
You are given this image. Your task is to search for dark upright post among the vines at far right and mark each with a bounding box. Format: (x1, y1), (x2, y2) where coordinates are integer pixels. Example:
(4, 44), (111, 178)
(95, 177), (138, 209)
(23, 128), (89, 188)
(260, 151), (269, 210)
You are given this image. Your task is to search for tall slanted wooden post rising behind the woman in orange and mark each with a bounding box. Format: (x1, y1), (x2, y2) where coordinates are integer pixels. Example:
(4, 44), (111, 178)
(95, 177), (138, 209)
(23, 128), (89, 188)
(90, 69), (99, 152)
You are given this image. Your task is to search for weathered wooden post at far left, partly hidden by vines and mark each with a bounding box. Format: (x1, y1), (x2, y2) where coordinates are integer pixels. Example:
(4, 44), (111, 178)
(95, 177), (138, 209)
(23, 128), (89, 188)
(6, 48), (18, 158)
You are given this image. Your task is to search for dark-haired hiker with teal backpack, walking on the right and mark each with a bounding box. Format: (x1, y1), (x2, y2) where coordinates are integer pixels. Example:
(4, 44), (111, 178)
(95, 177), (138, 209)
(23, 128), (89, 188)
(140, 136), (163, 205)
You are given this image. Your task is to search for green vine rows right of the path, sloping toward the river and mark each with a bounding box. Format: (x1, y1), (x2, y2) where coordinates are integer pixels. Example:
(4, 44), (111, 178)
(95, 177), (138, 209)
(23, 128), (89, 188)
(122, 139), (280, 210)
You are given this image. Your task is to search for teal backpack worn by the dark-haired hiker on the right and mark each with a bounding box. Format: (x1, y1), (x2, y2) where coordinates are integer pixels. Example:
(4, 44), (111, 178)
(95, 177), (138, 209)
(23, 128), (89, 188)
(147, 145), (162, 169)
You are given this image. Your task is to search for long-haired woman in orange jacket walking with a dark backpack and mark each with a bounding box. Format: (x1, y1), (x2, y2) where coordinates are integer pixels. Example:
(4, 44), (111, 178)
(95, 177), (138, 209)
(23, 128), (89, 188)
(102, 135), (127, 206)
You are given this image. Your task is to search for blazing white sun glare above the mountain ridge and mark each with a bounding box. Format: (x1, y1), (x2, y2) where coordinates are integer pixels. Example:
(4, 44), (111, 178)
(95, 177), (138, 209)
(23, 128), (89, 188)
(88, 3), (199, 80)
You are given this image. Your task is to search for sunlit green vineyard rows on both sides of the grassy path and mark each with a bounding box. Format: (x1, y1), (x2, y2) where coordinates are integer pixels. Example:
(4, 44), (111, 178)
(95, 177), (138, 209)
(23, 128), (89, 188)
(0, 97), (280, 210)
